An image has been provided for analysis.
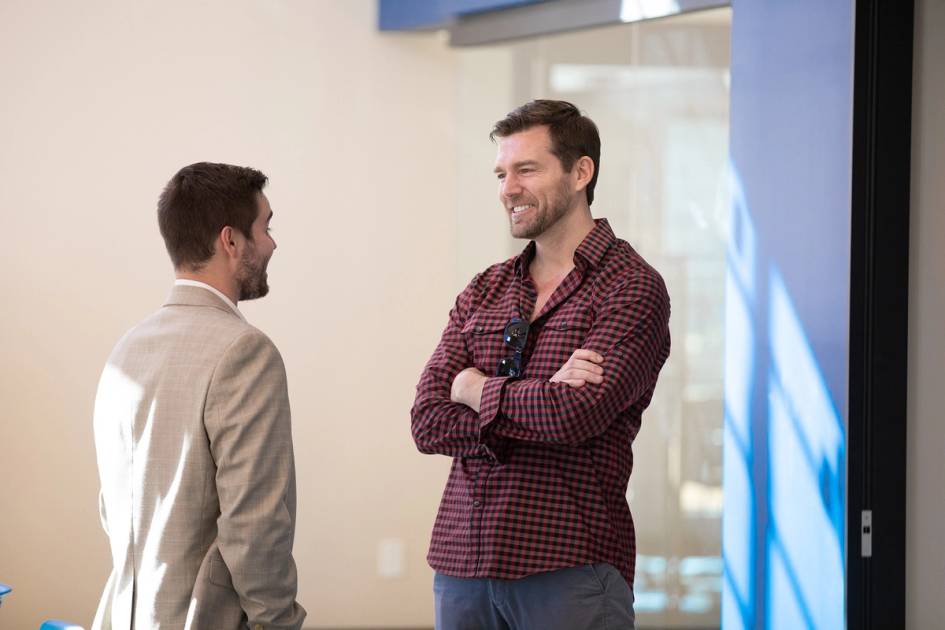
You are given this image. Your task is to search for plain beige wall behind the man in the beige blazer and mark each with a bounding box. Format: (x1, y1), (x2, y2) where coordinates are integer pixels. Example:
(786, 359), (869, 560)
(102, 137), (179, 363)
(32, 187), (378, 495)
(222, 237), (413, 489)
(0, 0), (460, 628)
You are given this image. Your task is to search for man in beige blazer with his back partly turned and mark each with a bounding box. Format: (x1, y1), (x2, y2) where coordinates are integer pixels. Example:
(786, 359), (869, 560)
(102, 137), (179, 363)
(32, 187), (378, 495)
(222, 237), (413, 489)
(93, 163), (305, 630)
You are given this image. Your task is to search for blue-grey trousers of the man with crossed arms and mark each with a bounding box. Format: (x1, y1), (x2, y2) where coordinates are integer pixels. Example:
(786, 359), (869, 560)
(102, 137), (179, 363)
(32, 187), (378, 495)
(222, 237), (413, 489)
(433, 564), (634, 630)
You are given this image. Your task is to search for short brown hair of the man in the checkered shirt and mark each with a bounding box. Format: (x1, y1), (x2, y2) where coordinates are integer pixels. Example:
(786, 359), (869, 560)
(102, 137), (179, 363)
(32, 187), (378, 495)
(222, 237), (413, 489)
(489, 100), (600, 205)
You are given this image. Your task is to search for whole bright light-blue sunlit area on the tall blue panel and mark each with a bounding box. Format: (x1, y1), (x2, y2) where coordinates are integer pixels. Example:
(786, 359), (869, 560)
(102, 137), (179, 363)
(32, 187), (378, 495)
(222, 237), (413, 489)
(722, 169), (846, 630)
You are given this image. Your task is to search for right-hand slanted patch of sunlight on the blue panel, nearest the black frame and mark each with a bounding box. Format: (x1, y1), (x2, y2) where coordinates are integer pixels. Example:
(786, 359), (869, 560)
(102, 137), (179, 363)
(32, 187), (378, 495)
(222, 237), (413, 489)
(767, 270), (846, 628)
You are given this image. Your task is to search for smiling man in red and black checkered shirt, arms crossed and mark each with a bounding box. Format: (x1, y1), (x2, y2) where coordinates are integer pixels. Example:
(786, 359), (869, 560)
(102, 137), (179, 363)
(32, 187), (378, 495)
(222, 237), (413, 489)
(411, 100), (670, 630)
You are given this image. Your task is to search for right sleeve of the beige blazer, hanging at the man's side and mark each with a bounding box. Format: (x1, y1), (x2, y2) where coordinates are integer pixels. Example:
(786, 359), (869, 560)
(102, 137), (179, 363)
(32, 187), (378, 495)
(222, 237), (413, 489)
(204, 329), (305, 629)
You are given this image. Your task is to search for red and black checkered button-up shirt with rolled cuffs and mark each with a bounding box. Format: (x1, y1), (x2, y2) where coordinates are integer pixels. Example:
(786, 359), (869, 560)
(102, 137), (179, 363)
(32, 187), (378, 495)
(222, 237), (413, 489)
(411, 219), (669, 585)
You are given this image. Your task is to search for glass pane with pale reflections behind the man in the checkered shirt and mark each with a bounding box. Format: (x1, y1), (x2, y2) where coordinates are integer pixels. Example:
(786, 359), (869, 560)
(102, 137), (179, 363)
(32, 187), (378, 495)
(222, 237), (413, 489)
(457, 3), (733, 628)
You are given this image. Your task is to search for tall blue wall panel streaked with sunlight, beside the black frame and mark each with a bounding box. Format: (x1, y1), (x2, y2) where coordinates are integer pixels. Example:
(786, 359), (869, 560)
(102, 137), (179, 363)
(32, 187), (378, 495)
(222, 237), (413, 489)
(722, 0), (853, 630)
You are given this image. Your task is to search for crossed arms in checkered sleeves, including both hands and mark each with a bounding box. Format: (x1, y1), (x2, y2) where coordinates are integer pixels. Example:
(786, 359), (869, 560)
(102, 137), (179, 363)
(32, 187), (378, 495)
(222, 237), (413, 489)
(411, 271), (669, 457)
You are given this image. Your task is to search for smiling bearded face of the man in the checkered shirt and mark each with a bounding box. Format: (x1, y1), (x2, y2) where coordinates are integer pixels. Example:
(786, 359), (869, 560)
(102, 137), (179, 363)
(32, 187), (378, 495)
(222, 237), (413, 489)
(495, 125), (576, 239)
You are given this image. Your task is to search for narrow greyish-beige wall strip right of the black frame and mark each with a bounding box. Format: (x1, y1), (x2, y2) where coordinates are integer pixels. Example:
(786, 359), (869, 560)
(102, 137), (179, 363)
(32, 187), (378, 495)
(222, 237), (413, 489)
(906, 0), (945, 630)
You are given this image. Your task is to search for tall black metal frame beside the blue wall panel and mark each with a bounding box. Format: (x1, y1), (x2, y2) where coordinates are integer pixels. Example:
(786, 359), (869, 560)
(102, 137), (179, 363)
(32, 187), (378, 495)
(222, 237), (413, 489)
(847, 0), (914, 630)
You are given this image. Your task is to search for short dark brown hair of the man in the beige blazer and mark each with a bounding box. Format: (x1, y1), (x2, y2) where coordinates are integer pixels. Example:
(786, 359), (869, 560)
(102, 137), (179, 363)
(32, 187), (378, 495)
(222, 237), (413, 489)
(158, 162), (269, 269)
